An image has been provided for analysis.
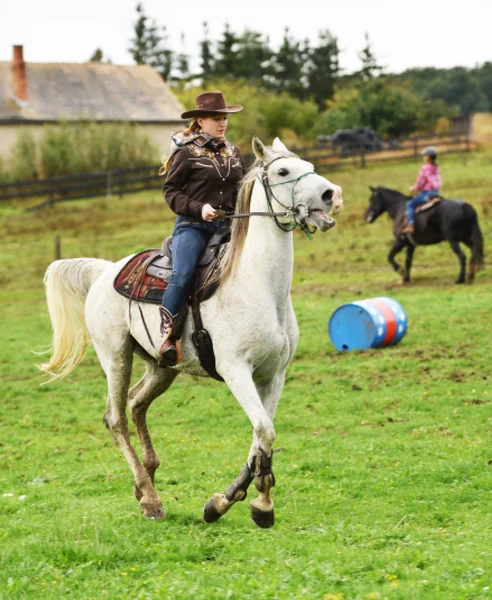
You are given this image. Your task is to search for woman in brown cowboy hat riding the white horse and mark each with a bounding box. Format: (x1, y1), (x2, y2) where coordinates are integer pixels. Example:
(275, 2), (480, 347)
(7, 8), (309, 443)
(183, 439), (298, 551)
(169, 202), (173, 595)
(160, 90), (244, 365)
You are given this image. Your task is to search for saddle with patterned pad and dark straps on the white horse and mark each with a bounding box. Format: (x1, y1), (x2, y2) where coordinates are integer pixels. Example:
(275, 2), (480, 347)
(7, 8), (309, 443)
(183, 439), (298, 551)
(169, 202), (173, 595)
(113, 223), (231, 381)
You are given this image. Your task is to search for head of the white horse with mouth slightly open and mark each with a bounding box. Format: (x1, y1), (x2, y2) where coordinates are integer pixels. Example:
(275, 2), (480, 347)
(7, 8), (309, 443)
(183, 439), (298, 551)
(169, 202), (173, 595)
(253, 137), (343, 231)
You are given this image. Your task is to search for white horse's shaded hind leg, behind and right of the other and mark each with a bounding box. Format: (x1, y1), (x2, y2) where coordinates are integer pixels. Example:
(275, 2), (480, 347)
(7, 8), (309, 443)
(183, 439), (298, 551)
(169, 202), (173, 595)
(128, 360), (178, 501)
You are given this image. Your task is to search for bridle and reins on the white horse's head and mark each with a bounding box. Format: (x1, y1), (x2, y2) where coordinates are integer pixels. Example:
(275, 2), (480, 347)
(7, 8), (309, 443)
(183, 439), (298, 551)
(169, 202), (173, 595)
(216, 155), (316, 239)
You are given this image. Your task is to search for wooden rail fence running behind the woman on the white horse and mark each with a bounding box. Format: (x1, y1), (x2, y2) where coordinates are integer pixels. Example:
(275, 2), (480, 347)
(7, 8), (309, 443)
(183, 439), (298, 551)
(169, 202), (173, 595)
(0, 134), (475, 211)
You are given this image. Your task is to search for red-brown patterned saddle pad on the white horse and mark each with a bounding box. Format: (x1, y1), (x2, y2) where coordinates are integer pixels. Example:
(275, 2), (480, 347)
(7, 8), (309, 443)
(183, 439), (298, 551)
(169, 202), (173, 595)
(113, 227), (230, 304)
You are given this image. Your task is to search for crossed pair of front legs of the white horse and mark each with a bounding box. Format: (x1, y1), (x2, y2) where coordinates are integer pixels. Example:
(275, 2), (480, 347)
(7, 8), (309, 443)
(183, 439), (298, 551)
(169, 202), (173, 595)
(204, 370), (285, 527)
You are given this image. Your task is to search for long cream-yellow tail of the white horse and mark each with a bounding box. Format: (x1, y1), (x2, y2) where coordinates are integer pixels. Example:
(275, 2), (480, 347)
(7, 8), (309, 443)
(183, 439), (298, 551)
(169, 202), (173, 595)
(38, 258), (111, 383)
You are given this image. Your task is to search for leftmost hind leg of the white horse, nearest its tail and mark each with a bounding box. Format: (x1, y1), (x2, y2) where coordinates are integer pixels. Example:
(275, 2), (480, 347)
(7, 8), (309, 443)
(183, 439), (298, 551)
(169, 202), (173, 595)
(94, 340), (165, 520)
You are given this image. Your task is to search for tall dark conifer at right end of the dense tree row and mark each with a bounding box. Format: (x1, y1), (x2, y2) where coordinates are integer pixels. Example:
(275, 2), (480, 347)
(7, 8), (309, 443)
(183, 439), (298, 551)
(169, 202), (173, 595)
(306, 29), (340, 111)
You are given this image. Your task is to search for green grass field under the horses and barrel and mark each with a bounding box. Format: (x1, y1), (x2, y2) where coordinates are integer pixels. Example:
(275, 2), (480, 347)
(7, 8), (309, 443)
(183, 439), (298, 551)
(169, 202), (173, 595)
(0, 153), (492, 600)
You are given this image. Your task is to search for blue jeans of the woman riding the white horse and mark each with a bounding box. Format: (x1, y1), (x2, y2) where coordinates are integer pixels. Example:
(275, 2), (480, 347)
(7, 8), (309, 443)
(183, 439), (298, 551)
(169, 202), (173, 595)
(162, 215), (223, 316)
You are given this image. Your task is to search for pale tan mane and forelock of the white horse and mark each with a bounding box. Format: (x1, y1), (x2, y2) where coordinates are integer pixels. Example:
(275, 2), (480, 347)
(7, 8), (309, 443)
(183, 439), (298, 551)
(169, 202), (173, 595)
(218, 147), (299, 282)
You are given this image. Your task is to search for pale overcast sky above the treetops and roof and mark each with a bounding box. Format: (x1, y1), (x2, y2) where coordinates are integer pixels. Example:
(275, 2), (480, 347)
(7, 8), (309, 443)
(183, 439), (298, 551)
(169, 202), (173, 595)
(0, 0), (492, 72)
